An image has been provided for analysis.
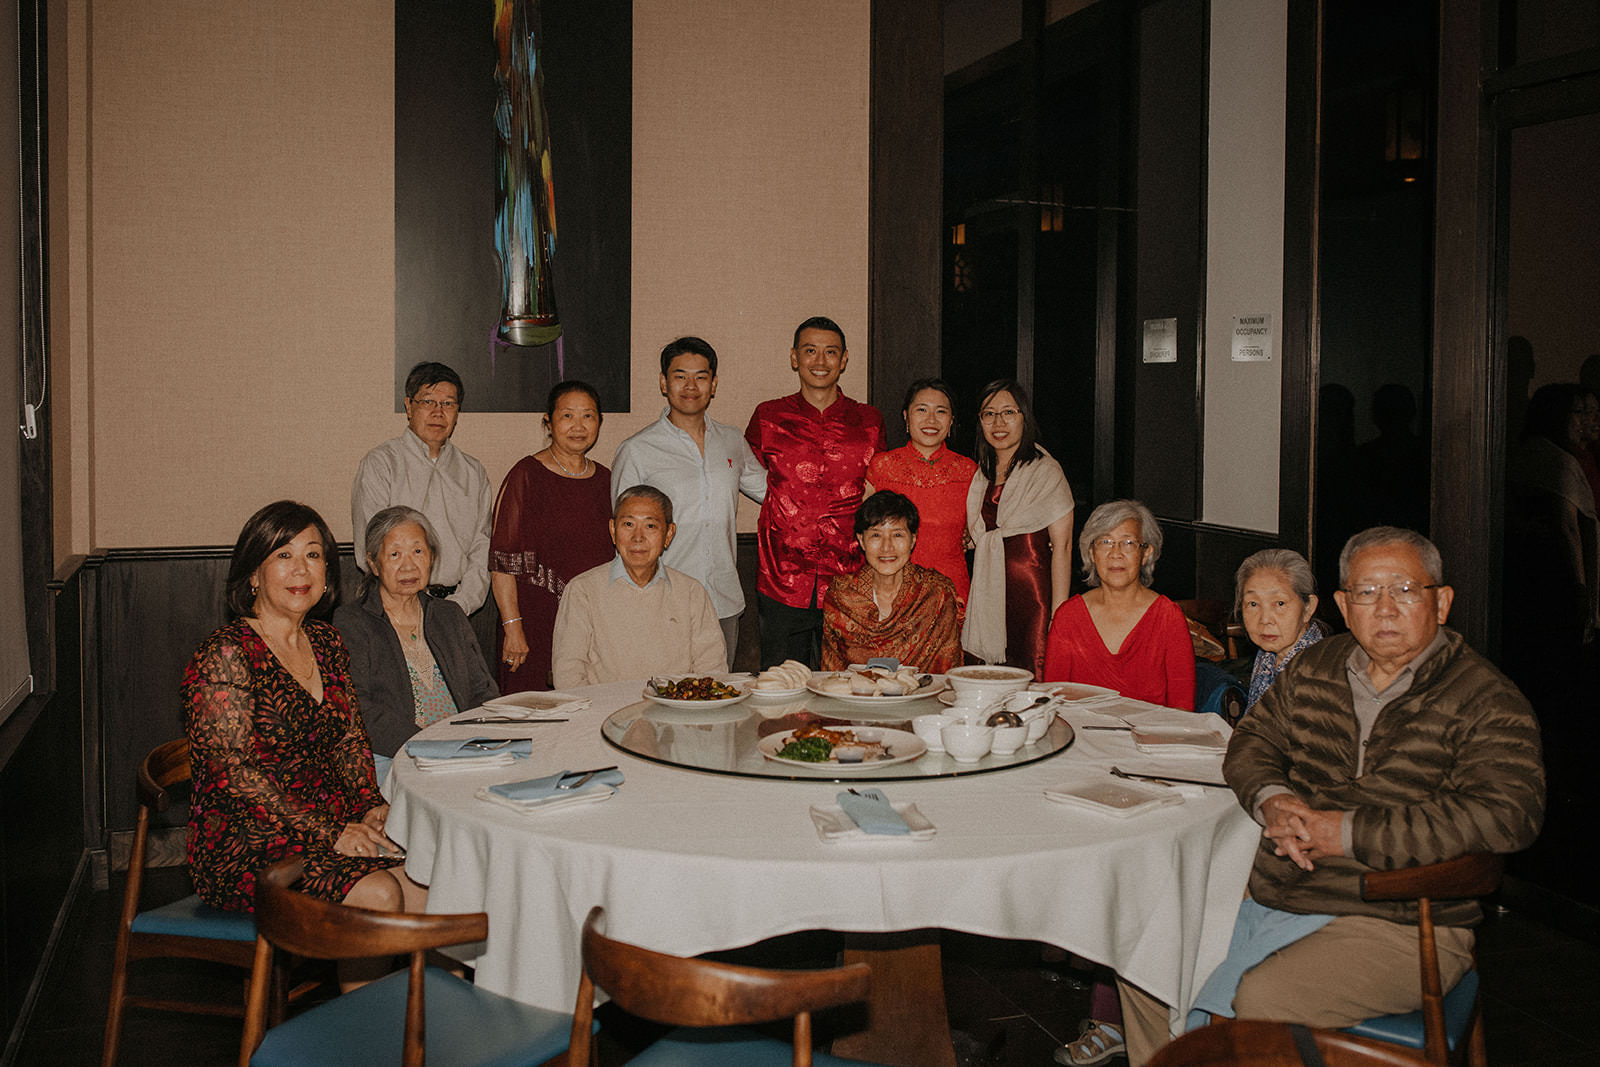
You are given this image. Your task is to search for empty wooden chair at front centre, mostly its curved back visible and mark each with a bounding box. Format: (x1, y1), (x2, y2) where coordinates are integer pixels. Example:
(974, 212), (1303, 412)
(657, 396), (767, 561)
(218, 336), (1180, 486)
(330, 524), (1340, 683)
(568, 907), (872, 1067)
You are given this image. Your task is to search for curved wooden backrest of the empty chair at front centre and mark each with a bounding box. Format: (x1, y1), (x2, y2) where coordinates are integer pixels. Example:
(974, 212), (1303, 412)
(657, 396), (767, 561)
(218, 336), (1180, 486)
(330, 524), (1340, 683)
(571, 907), (872, 1064)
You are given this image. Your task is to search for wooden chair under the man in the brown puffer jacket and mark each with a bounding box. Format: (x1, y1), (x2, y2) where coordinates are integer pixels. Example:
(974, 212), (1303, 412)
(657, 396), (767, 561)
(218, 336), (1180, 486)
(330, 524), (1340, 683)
(1344, 853), (1506, 1067)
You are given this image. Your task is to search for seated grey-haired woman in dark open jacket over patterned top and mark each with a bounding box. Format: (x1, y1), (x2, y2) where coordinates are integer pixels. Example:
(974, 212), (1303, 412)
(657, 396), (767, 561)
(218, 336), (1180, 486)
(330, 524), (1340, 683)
(333, 507), (499, 755)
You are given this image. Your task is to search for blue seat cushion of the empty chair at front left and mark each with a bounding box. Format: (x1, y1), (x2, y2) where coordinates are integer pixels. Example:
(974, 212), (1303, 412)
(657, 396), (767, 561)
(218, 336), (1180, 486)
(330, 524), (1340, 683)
(250, 968), (573, 1067)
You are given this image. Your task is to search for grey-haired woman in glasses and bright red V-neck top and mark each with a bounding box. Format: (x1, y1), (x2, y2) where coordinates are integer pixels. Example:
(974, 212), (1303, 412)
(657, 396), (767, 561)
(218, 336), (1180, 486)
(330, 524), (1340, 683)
(1045, 501), (1195, 712)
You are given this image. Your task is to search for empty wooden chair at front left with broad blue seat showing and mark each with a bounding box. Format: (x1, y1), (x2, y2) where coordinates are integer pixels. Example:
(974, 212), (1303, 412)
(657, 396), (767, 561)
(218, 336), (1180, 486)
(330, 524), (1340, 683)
(238, 859), (571, 1067)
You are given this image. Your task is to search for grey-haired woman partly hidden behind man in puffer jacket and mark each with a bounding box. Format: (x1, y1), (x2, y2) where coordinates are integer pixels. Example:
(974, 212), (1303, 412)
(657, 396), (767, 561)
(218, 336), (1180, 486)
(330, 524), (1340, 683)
(1234, 549), (1328, 712)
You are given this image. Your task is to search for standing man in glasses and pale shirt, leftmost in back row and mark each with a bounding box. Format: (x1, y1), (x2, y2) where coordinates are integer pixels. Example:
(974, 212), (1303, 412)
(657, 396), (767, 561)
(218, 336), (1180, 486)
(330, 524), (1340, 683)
(350, 363), (496, 654)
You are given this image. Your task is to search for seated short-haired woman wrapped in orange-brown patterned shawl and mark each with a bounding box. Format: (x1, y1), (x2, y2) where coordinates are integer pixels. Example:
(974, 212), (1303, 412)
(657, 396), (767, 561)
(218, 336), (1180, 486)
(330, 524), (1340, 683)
(822, 491), (962, 673)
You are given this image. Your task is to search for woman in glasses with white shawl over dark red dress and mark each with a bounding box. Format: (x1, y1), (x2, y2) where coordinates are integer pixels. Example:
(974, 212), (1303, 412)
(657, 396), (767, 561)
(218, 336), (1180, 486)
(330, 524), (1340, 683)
(962, 379), (1072, 677)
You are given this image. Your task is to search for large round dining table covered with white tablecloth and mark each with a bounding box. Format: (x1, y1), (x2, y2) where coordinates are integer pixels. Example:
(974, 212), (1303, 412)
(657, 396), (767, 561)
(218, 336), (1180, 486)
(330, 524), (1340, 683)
(384, 681), (1259, 1064)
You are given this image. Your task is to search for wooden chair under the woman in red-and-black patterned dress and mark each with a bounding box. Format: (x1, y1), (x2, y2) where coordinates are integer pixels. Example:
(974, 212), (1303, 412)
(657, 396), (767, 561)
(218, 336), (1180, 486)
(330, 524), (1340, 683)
(101, 737), (256, 1067)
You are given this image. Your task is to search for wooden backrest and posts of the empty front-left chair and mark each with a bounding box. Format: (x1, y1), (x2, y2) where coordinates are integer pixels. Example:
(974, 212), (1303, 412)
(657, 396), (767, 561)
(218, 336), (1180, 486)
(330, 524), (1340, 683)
(240, 857), (490, 1067)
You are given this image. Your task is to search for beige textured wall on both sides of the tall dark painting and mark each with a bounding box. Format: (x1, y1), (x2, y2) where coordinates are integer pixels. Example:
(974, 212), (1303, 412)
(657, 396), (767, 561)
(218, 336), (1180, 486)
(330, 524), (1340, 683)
(81, 0), (869, 547)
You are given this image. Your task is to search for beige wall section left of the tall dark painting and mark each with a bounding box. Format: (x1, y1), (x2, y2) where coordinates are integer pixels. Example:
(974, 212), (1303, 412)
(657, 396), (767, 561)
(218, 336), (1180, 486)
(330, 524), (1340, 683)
(88, 0), (394, 547)
